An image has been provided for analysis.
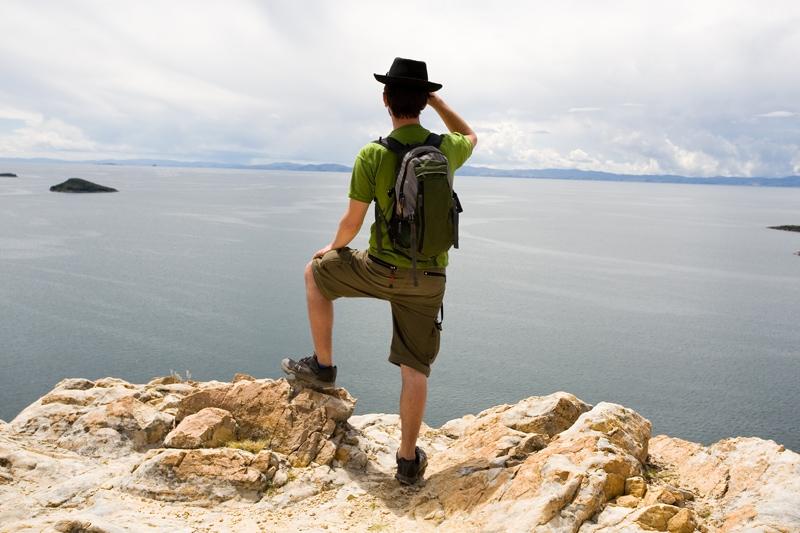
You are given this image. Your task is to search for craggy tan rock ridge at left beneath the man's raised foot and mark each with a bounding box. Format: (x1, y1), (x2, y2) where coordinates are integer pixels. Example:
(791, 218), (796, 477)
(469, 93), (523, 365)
(11, 376), (355, 466)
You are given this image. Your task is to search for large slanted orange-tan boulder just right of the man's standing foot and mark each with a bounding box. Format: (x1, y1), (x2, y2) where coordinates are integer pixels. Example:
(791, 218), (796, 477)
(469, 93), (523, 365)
(417, 393), (650, 531)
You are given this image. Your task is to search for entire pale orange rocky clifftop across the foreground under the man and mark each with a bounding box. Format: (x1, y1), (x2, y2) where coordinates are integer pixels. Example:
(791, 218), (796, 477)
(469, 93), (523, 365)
(0, 374), (800, 533)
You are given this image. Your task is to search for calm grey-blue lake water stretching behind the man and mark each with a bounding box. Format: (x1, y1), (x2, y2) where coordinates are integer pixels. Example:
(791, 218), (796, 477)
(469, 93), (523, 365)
(0, 164), (800, 450)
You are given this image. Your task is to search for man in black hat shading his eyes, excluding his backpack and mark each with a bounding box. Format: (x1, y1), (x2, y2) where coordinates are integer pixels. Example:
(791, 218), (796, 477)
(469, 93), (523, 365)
(281, 57), (478, 485)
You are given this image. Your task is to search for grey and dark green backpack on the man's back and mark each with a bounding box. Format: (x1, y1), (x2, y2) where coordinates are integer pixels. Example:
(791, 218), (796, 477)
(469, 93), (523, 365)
(375, 133), (463, 286)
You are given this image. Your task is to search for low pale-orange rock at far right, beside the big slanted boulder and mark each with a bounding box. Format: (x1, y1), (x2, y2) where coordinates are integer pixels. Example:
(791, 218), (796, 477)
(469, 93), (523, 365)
(580, 435), (800, 533)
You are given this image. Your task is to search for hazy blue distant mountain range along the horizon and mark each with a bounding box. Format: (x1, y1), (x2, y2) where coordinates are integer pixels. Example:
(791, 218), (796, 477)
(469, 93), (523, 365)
(0, 158), (800, 187)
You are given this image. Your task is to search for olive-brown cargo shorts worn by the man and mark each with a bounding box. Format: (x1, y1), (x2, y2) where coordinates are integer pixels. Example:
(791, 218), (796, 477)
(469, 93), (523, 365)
(311, 247), (446, 376)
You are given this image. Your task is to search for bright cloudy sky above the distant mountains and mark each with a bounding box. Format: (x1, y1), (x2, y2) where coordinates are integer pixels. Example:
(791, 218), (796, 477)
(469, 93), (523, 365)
(0, 0), (800, 177)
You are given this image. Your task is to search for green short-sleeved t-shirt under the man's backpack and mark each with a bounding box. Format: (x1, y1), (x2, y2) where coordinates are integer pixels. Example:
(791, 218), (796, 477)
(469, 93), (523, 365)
(348, 124), (472, 268)
